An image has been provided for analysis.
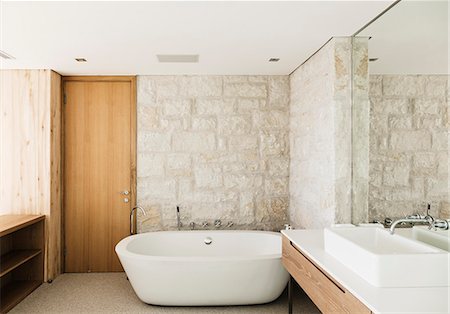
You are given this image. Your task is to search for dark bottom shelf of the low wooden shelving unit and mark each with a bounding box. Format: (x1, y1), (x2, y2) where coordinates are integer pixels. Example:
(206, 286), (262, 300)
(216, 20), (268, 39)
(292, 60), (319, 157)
(0, 280), (41, 313)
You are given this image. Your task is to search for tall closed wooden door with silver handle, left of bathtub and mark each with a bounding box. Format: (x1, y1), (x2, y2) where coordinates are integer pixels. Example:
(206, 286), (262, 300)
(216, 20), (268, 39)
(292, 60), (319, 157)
(64, 77), (136, 272)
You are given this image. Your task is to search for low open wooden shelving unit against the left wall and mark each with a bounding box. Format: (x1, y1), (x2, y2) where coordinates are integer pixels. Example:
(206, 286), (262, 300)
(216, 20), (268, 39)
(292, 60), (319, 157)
(0, 215), (45, 313)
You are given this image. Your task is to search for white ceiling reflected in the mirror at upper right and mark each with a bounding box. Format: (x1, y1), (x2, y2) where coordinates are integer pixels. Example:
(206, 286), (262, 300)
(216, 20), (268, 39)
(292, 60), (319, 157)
(358, 0), (450, 74)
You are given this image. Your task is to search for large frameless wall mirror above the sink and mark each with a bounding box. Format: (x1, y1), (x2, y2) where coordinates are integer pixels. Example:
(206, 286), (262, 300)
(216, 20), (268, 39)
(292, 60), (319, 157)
(352, 0), (450, 223)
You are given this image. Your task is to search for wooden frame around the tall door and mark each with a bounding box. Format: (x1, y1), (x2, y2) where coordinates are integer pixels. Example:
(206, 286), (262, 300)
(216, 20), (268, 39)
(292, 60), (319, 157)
(61, 75), (137, 273)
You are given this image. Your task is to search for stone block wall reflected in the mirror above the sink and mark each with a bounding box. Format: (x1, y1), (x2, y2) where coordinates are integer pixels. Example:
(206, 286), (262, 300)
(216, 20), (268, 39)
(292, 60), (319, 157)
(369, 75), (450, 220)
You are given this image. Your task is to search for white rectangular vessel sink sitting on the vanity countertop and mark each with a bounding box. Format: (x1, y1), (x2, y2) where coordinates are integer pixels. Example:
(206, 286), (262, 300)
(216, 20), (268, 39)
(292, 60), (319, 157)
(324, 227), (450, 287)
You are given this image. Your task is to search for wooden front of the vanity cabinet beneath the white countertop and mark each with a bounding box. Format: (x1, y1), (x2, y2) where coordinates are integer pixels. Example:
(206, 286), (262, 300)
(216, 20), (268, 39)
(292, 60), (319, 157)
(282, 235), (371, 313)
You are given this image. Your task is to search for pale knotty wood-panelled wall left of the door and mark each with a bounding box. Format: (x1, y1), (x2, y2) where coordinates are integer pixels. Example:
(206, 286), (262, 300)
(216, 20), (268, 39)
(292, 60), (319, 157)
(0, 70), (62, 280)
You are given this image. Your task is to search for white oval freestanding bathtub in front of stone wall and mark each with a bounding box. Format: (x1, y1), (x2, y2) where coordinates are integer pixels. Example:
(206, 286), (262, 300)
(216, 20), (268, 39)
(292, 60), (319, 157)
(116, 231), (289, 306)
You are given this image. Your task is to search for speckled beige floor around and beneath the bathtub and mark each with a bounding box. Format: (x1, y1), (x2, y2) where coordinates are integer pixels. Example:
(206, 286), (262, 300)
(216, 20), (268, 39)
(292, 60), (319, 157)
(10, 273), (320, 314)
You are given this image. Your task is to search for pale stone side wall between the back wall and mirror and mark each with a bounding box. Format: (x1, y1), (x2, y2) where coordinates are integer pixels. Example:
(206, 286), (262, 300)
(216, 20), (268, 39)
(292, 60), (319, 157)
(289, 38), (352, 228)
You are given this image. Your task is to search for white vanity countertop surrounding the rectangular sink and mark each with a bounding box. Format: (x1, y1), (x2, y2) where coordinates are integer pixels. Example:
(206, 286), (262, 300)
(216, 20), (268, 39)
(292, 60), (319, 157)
(281, 229), (450, 314)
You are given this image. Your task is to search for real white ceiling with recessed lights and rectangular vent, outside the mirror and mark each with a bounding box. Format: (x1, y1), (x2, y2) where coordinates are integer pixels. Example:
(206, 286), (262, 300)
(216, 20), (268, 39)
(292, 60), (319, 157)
(0, 0), (393, 75)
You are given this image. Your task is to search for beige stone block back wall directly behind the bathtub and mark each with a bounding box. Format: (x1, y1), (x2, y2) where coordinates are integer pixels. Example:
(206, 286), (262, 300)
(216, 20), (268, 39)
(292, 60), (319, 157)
(137, 76), (289, 232)
